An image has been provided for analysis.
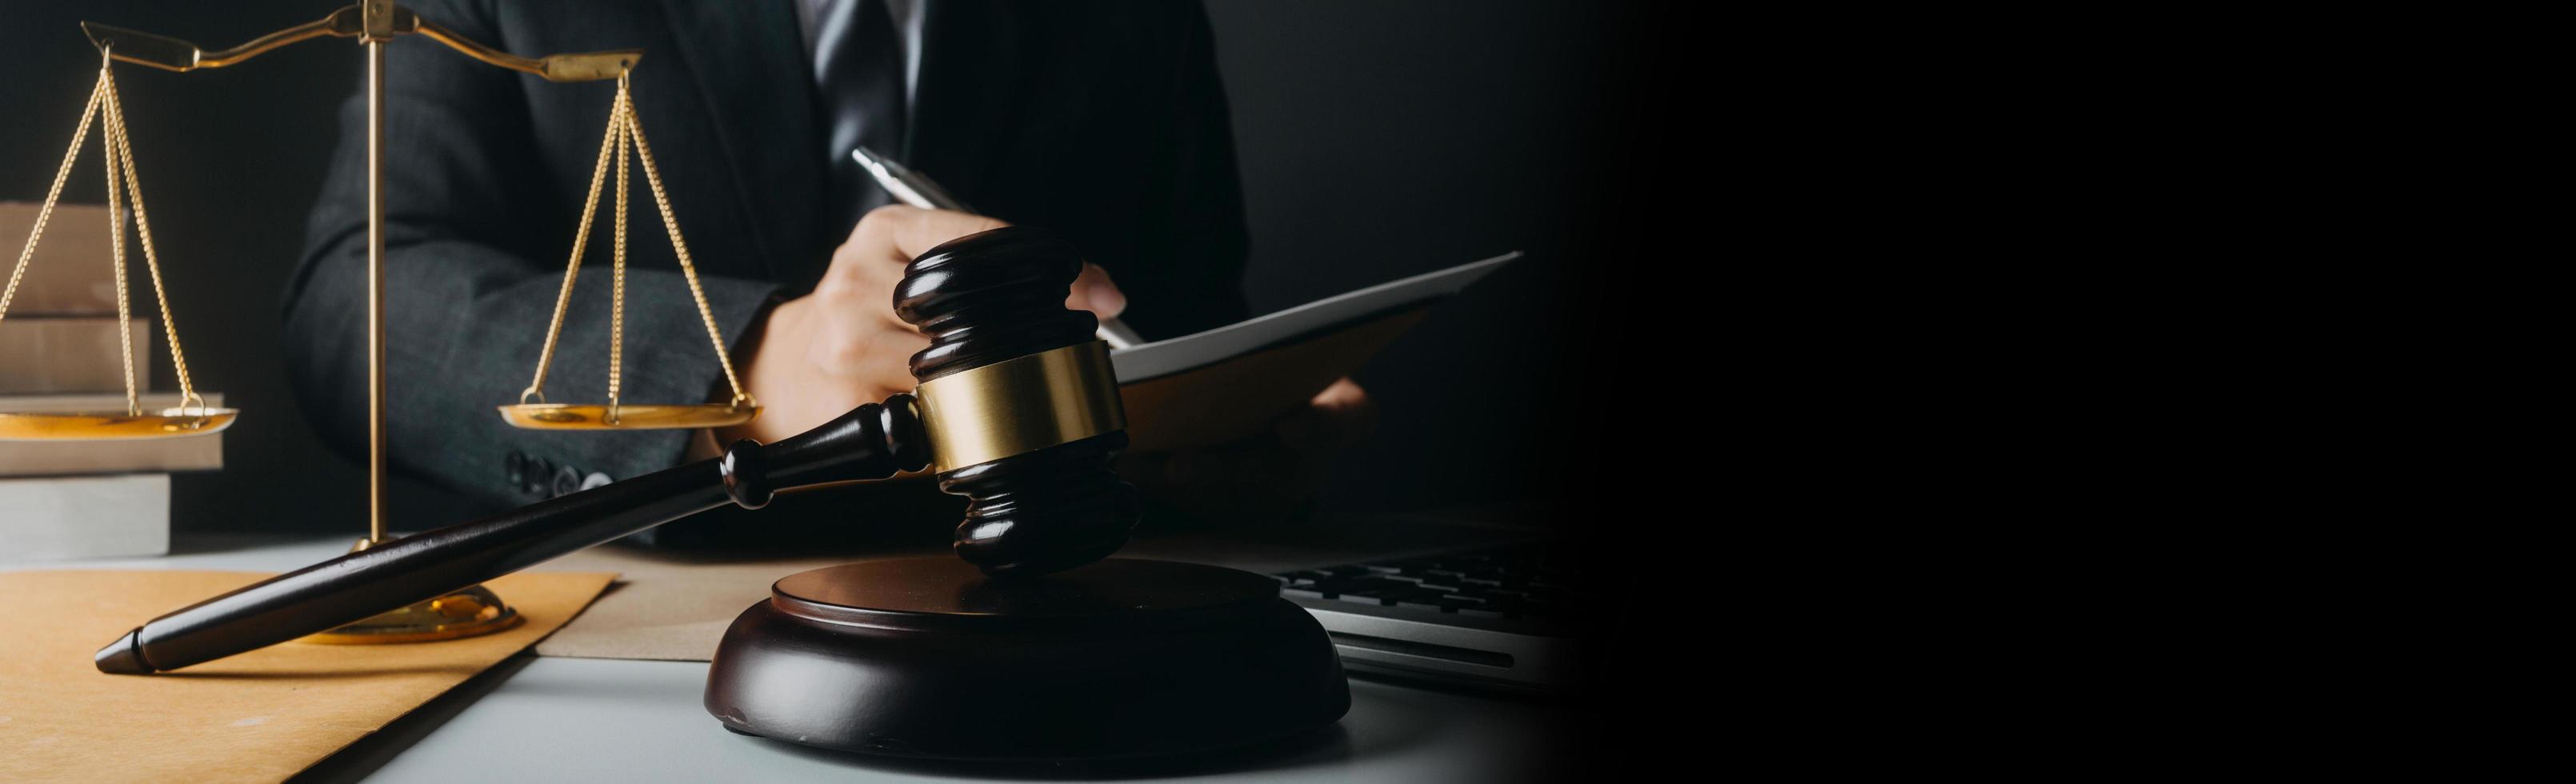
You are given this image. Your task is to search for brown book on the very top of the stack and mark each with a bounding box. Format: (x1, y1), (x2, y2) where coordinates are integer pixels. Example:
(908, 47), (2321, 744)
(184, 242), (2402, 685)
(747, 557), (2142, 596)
(0, 201), (121, 320)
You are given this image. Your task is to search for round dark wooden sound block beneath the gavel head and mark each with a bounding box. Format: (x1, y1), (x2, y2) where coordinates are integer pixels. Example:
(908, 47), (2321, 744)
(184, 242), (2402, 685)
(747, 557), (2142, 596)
(706, 557), (1350, 761)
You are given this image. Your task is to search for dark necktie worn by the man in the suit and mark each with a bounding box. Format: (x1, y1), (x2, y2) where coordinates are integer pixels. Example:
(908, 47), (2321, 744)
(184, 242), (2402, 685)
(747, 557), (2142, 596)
(814, 0), (904, 238)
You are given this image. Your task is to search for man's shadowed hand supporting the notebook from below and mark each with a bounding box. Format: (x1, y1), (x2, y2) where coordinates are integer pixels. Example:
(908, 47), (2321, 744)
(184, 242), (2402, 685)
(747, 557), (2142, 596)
(1118, 377), (1378, 523)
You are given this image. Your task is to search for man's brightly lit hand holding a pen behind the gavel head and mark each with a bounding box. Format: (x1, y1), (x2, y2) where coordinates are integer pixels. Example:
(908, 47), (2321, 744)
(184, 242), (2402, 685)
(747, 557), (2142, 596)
(716, 206), (1126, 443)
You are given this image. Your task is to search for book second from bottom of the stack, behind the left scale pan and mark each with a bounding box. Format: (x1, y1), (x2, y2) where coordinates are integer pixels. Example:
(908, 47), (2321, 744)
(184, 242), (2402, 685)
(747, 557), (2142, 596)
(0, 392), (224, 477)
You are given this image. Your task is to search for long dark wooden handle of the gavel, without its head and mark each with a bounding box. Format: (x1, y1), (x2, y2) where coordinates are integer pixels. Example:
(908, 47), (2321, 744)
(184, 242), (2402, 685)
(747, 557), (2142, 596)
(95, 394), (927, 676)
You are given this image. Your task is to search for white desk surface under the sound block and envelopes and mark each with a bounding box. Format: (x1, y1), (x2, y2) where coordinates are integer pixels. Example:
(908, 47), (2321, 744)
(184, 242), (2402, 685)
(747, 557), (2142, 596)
(0, 537), (1597, 782)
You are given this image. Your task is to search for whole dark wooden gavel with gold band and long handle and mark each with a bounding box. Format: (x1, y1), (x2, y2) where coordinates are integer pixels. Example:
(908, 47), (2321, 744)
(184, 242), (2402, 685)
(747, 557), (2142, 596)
(95, 227), (1138, 673)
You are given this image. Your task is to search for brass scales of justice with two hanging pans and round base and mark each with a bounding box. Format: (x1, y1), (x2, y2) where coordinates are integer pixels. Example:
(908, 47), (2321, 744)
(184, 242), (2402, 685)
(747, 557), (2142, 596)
(0, 0), (760, 642)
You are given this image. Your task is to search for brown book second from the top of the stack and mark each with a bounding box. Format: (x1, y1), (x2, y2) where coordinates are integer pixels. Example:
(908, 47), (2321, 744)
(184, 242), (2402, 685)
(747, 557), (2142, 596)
(0, 314), (160, 394)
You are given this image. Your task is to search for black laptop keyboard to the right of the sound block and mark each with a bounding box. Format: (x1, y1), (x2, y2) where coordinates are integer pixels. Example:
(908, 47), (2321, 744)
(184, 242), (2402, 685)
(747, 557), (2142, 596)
(1273, 546), (1605, 622)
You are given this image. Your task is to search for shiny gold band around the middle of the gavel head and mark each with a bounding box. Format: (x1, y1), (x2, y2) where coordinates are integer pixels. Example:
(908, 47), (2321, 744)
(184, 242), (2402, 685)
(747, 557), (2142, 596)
(912, 341), (1126, 472)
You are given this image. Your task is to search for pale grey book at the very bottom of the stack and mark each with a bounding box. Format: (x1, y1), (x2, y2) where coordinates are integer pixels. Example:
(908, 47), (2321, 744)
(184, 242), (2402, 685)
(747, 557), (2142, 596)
(0, 474), (170, 562)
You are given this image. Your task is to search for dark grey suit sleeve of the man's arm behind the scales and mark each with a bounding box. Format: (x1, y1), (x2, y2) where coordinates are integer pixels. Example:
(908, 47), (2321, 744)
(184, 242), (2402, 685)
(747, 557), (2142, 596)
(286, 2), (775, 515)
